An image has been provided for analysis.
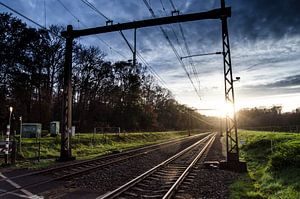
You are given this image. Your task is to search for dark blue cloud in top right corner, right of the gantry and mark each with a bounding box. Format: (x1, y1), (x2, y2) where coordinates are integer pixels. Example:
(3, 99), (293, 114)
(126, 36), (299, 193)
(229, 0), (300, 40)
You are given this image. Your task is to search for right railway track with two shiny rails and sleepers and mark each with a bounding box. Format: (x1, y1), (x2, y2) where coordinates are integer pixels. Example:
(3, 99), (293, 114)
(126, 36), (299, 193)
(97, 134), (216, 199)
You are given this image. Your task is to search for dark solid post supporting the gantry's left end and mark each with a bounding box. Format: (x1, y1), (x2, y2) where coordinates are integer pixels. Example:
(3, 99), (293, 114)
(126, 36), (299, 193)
(59, 25), (74, 161)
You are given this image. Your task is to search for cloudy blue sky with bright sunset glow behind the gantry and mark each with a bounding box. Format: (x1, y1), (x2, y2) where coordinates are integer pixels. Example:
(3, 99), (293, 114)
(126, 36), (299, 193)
(0, 0), (300, 114)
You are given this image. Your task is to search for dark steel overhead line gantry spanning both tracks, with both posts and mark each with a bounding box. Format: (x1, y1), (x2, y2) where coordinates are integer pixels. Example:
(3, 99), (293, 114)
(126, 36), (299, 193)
(60, 0), (244, 172)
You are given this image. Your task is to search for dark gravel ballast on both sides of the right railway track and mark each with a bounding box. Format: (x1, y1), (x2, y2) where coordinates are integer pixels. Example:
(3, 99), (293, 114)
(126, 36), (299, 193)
(43, 132), (239, 199)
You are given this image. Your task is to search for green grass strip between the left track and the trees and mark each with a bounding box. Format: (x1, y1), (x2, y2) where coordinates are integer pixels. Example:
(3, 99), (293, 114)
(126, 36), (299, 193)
(3, 131), (199, 168)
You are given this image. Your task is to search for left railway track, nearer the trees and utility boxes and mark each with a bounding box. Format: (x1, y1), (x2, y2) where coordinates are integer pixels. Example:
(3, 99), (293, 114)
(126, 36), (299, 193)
(0, 133), (208, 198)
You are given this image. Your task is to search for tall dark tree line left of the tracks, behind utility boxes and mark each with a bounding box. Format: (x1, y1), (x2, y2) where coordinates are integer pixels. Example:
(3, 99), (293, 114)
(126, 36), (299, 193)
(0, 13), (218, 132)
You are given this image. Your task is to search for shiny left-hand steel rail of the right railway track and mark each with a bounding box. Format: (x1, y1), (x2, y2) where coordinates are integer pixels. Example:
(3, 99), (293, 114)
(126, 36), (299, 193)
(96, 135), (215, 199)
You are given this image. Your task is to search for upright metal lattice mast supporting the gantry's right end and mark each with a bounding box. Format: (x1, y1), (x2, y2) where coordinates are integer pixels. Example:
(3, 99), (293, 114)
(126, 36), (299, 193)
(221, 0), (239, 162)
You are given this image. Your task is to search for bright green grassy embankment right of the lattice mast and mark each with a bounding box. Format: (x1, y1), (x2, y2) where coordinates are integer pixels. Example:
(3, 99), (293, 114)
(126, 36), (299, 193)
(230, 130), (300, 199)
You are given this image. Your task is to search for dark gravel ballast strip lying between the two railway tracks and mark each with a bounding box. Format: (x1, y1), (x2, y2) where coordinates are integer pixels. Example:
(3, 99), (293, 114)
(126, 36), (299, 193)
(76, 134), (207, 195)
